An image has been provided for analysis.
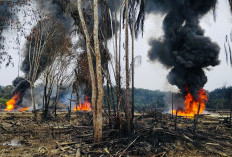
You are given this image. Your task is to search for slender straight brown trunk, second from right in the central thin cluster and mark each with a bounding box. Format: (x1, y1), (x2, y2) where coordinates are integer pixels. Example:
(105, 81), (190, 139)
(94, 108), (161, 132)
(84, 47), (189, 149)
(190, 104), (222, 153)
(125, 0), (131, 133)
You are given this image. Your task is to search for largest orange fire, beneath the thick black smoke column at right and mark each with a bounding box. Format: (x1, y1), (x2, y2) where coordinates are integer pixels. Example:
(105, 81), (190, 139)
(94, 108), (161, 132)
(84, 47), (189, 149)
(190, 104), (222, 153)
(173, 88), (208, 118)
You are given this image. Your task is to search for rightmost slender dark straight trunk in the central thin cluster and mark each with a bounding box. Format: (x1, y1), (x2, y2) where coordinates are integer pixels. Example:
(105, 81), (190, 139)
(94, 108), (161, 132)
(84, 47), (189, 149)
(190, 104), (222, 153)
(131, 1), (135, 129)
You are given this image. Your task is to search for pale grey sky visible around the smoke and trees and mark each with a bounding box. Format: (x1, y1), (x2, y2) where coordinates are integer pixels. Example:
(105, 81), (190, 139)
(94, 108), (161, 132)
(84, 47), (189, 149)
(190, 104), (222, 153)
(0, 0), (232, 91)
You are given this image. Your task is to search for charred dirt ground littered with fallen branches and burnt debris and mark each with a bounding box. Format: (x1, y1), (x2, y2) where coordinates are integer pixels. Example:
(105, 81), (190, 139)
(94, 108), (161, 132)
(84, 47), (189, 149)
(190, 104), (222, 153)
(0, 112), (232, 157)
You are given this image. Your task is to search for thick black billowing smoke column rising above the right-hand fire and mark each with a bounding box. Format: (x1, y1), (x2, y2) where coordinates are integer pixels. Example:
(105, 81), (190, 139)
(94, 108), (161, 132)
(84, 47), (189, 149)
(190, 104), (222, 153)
(147, 0), (220, 96)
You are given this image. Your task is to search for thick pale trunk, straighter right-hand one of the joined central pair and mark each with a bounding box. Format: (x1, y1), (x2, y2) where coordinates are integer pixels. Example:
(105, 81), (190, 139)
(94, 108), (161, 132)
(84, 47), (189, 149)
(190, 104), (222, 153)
(93, 0), (104, 143)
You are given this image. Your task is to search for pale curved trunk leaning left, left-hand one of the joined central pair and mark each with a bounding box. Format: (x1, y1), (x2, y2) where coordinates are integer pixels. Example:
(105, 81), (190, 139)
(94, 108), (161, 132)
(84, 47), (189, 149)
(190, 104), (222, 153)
(77, 0), (97, 141)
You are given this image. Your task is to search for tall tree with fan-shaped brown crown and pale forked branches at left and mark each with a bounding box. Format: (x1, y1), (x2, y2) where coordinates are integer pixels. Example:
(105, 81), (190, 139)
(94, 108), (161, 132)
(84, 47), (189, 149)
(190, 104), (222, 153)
(25, 18), (66, 120)
